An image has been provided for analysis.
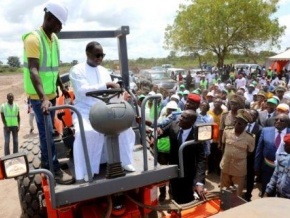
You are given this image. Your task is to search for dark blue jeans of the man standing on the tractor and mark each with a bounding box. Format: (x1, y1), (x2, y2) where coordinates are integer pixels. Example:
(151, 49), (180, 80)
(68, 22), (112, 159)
(31, 99), (60, 172)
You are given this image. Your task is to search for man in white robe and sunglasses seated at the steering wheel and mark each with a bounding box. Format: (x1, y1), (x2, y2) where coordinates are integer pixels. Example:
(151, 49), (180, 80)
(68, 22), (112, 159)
(70, 42), (135, 180)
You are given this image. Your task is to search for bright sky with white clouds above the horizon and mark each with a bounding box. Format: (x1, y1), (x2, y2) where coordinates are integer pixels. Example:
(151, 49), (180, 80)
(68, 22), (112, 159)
(0, 0), (290, 64)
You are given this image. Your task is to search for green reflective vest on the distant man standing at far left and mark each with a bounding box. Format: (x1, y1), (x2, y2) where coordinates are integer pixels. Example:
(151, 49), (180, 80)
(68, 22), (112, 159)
(1, 103), (19, 126)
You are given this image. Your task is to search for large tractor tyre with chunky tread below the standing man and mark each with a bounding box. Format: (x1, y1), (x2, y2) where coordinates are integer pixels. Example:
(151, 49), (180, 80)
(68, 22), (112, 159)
(17, 137), (47, 218)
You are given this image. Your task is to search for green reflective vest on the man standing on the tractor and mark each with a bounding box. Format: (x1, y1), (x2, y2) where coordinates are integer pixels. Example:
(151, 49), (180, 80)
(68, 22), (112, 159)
(22, 29), (59, 95)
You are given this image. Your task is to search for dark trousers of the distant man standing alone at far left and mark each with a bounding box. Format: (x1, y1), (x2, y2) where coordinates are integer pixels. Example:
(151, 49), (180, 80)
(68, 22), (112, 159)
(3, 126), (18, 155)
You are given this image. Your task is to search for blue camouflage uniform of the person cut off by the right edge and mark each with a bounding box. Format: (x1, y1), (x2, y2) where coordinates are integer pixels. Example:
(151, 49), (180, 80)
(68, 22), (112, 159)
(266, 152), (290, 199)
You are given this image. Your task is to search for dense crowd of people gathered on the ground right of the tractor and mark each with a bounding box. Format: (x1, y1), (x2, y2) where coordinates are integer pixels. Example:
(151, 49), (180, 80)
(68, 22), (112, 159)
(137, 66), (290, 203)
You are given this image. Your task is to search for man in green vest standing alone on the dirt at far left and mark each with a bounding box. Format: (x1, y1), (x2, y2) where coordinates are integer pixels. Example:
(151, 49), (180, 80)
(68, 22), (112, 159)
(1, 93), (20, 155)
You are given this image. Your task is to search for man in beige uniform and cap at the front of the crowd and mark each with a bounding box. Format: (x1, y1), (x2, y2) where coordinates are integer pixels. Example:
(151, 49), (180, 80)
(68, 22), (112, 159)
(220, 109), (255, 196)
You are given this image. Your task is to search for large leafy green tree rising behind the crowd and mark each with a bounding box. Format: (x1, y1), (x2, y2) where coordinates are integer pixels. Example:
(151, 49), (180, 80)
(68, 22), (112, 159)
(164, 0), (286, 66)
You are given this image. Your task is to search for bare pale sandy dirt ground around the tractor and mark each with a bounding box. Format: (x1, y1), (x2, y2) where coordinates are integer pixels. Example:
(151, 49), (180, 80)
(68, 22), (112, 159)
(0, 74), (259, 218)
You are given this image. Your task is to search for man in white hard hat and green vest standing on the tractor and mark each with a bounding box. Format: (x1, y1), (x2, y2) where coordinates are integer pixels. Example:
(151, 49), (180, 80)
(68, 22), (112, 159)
(22, 1), (74, 184)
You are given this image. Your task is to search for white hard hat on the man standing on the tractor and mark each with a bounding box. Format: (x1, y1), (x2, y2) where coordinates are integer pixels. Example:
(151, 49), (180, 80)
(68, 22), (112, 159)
(45, 0), (68, 25)
